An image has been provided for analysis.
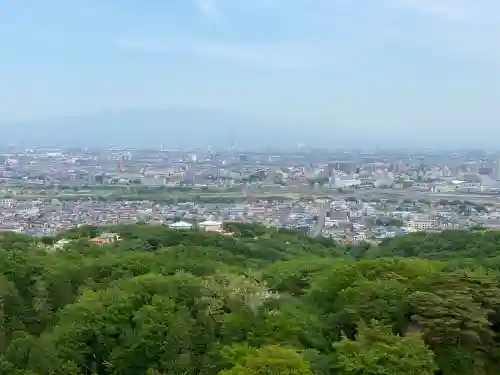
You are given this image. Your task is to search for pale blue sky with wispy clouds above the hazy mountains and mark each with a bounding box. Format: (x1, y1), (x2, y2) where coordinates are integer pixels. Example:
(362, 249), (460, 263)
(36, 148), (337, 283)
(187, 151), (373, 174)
(0, 0), (500, 143)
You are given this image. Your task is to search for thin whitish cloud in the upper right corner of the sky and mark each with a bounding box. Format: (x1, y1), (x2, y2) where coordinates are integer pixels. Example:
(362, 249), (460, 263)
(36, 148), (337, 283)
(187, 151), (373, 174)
(308, 0), (500, 63)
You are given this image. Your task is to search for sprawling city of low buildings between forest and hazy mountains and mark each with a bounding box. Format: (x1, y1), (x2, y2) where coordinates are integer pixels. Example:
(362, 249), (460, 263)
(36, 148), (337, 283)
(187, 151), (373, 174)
(0, 146), (500, 243)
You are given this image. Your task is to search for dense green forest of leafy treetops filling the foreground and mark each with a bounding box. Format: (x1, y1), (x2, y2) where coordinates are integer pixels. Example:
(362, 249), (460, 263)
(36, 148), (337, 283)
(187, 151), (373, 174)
(0, 223), (500, 375)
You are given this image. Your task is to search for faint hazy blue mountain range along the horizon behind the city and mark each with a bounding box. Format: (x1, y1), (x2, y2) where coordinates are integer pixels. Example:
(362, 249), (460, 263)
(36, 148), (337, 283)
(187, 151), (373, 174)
(0, 108), (490, 149)
